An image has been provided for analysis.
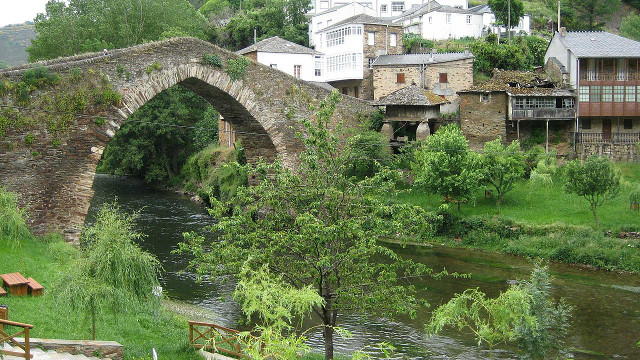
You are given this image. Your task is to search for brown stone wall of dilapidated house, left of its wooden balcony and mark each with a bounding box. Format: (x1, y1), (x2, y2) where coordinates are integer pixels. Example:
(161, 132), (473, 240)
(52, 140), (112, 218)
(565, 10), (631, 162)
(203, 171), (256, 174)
(460, 92), (508, 149)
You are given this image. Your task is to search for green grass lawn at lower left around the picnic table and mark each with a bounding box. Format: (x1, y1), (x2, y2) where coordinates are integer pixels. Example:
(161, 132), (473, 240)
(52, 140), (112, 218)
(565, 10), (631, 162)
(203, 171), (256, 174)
(0, 239), (200, 360)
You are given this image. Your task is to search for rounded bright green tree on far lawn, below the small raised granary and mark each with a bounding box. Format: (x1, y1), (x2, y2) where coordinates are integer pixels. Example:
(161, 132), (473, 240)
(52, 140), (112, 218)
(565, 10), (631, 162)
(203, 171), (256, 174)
(411, 124), (483, 209)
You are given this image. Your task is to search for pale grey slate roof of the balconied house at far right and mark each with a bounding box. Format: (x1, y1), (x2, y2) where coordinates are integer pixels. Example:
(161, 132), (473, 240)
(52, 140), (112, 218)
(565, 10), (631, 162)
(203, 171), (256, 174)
(555, 31), (640, 58)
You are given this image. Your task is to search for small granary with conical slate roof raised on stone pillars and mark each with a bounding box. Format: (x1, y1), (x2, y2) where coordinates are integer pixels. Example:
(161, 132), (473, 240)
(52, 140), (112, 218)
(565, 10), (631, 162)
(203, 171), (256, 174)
(375, 85), (449, 148)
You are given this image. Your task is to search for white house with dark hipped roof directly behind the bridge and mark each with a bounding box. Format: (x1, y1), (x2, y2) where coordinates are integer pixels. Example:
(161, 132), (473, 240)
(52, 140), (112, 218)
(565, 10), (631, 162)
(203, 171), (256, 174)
(236, 36), (324, 82)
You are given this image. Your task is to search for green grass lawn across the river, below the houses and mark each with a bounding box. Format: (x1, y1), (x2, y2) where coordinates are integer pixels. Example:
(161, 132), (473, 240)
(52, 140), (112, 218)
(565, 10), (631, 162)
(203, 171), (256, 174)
(397, 163), (640, 231)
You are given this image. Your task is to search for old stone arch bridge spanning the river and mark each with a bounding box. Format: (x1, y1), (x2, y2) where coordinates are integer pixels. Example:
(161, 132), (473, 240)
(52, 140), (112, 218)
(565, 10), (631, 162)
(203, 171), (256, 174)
(0, 38), (373, 241)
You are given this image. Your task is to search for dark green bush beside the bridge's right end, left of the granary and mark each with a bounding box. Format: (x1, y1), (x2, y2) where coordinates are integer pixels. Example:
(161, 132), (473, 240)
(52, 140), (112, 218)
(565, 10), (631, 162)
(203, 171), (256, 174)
(345, 131), (392, 180)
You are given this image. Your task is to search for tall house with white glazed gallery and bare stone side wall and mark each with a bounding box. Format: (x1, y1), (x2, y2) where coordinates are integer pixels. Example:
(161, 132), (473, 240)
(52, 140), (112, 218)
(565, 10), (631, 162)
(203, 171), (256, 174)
(315, 14), (403, 100)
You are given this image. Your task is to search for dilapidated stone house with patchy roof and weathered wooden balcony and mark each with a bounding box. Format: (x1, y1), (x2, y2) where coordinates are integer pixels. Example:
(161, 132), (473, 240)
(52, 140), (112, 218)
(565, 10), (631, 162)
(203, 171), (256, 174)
(458, 70), (576, 150)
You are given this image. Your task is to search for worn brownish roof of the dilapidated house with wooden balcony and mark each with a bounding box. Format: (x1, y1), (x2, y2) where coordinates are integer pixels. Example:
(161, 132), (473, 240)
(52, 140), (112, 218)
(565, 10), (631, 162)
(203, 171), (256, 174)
(458, 69), (575, 96)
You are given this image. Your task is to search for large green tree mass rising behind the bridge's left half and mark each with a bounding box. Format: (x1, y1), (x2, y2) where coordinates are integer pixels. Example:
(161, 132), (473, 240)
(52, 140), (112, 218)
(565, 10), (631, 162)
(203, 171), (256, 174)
(27, 0), (206, 61)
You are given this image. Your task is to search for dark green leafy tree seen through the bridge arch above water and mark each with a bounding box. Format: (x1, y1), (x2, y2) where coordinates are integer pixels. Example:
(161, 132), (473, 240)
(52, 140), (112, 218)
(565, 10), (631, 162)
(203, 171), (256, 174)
(98, 86), (218, 185)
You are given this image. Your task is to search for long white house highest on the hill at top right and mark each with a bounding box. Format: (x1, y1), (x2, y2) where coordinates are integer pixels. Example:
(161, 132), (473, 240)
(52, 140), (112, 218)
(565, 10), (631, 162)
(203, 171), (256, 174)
(394, 0), (531, 40)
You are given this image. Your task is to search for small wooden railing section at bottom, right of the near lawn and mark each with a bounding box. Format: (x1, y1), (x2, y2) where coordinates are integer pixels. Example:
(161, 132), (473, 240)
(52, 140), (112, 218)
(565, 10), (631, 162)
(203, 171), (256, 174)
(189, 321), (245, 358)
